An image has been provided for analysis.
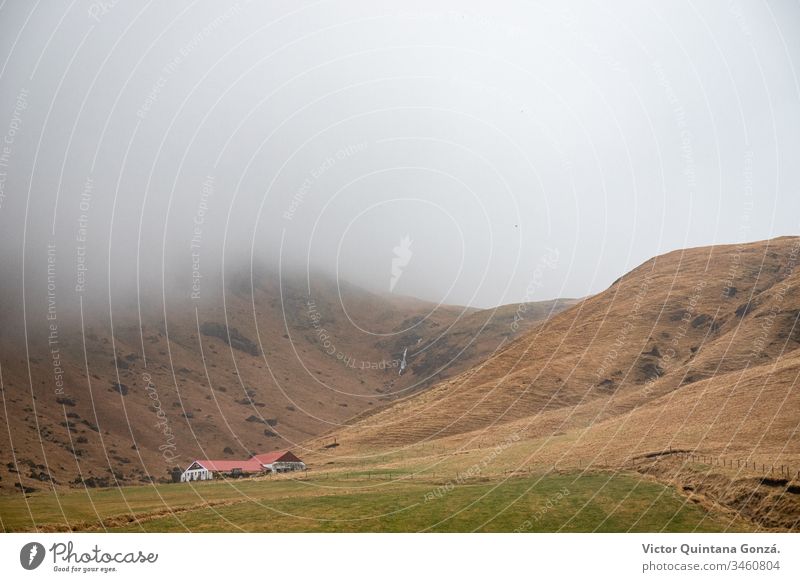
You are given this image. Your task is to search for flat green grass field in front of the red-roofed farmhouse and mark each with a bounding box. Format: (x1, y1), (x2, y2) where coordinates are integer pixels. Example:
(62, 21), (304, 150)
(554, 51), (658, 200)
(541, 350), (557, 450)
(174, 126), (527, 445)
(0, 473), (752, 532)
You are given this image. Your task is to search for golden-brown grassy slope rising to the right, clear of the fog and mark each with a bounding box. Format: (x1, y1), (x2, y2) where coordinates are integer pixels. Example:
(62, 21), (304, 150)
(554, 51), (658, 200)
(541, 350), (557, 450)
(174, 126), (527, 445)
(300, 237), (800, 531)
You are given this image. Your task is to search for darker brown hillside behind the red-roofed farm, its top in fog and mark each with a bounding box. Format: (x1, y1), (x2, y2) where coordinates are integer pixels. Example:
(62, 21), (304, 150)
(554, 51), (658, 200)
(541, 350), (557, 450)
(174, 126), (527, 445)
(0, 274), (569, 491)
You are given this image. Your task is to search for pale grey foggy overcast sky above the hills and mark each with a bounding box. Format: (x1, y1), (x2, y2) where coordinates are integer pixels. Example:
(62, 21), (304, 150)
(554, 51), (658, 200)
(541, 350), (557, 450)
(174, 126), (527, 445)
(0, 0), (800, 306)
